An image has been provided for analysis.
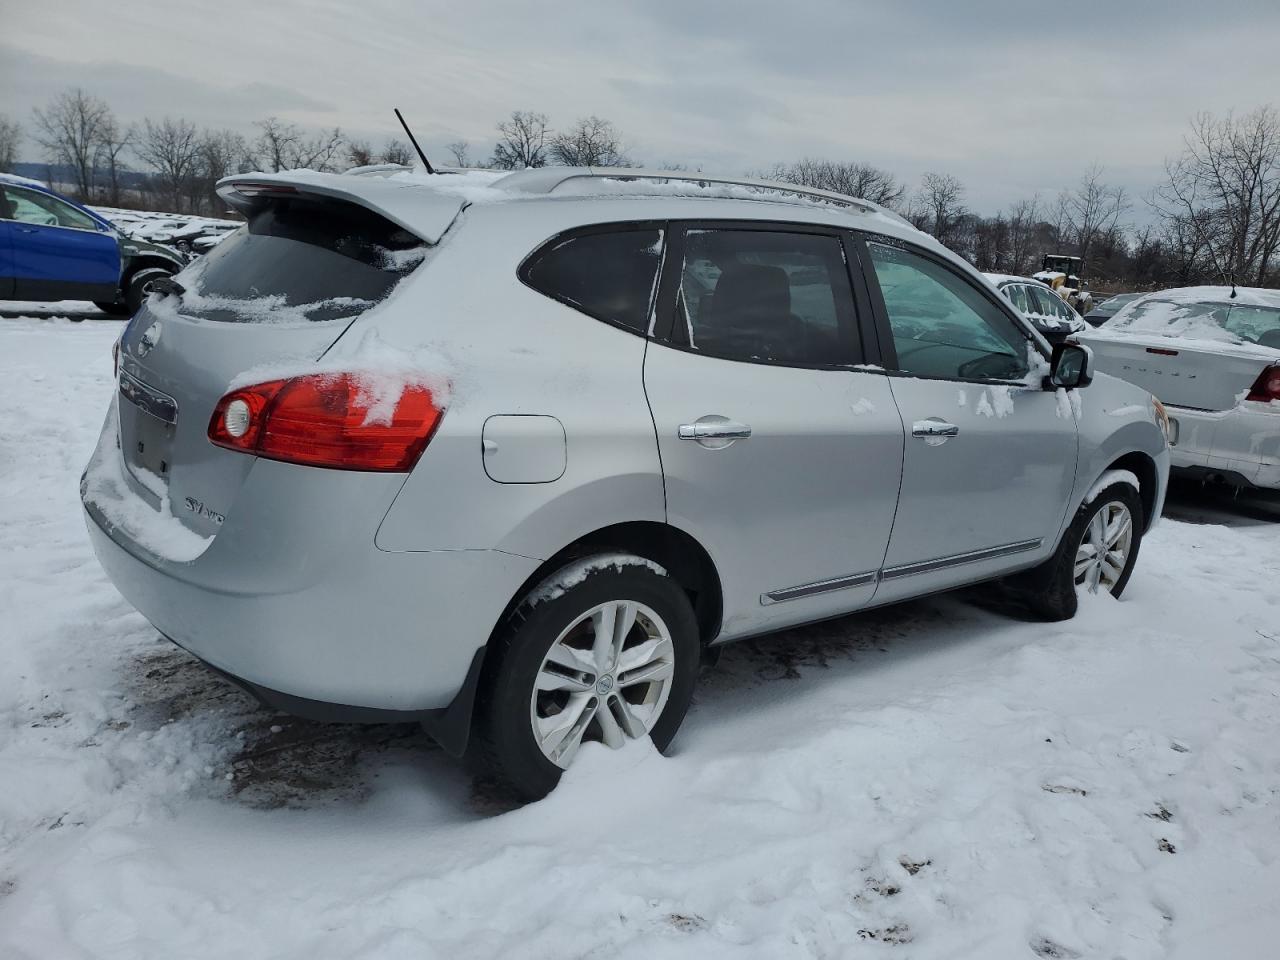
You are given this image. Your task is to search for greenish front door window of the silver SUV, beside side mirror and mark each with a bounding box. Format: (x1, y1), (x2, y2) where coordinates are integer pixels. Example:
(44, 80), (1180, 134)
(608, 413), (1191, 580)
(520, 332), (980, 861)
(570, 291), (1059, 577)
(867, 241), (1028, 380)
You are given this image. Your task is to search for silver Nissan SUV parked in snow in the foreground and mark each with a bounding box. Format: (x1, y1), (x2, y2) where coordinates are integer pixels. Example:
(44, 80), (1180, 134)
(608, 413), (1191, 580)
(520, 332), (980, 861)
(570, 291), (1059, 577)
(82, 168), (1169, 797)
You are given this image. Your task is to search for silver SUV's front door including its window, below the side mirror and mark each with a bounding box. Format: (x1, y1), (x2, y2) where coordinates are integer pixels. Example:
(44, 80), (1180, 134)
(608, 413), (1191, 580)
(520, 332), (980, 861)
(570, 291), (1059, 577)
(863, 238), (1078, 603)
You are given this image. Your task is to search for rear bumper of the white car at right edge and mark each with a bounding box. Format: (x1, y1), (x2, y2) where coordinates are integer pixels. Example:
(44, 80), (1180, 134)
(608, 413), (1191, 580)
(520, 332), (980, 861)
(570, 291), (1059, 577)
(1167, 402), (1280, 489)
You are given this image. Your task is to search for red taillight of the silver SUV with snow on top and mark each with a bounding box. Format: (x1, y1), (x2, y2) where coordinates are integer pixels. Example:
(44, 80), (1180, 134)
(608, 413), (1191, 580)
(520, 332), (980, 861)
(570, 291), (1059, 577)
(209, 374), (444, 472)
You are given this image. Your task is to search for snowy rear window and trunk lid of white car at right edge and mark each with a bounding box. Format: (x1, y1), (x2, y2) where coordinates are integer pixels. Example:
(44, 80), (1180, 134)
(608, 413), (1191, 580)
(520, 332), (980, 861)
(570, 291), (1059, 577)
(1078, 298), (1280, 411)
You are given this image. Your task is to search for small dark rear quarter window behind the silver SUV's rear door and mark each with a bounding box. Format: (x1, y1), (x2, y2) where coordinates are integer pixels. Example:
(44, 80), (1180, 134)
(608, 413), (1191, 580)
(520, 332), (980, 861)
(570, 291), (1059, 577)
(520, 227), (663, 334)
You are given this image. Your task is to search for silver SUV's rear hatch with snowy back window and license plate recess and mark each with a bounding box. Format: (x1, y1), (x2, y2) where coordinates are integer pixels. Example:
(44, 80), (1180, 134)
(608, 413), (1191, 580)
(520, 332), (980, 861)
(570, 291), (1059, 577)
(116, 180), (461, 538)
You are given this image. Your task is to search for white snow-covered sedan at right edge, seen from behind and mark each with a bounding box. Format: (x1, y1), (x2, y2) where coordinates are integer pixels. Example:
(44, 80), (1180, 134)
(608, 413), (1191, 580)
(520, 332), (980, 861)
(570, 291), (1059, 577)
(1076, 287), (1280, 489)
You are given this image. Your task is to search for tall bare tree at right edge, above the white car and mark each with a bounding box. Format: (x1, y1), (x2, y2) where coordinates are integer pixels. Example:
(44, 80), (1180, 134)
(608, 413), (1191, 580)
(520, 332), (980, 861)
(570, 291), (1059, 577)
(1153, 106), (1280, 287)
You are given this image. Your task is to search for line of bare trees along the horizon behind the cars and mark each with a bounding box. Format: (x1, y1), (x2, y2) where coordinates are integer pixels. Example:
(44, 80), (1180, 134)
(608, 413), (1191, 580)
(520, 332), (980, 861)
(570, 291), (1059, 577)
(0, 88), (1280, 288)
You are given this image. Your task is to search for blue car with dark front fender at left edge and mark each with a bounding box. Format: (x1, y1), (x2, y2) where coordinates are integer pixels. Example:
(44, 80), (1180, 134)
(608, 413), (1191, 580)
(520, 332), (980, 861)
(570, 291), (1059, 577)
(0, 174), (187, 316)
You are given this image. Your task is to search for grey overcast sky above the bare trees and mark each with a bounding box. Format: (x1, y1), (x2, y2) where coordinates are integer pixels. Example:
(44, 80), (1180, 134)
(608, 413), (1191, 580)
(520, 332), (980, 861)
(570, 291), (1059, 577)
(0, 0), (1280, 219)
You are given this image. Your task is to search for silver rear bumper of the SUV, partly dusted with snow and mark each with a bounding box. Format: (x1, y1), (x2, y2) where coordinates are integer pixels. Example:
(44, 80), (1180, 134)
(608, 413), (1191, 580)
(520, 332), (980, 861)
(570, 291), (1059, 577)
(86, 496), (538, 719)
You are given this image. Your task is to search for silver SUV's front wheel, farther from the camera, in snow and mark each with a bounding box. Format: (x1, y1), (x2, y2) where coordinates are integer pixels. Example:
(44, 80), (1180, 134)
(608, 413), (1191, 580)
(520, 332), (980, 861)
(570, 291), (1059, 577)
(1002, 481), (1143, 621)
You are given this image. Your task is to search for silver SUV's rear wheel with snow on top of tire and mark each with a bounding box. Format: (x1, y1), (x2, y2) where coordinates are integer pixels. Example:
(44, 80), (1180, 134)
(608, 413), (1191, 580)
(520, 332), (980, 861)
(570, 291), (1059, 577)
(472, 556), (700, 800)
